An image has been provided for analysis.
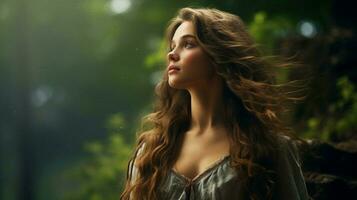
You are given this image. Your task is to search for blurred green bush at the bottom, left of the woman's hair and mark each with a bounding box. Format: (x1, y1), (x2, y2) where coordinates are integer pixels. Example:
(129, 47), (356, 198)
(67, 114), (132, 200)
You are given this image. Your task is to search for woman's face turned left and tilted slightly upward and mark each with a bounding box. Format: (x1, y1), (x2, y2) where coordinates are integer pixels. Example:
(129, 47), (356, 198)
(166, 21), (214, 89)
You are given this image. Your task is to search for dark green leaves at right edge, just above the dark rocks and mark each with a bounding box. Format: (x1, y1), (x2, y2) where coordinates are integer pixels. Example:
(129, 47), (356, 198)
(304, 77), (357, 141)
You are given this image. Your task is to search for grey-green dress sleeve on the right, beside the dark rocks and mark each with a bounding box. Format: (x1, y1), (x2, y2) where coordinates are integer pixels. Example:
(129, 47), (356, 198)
(275, 138), (310, 200)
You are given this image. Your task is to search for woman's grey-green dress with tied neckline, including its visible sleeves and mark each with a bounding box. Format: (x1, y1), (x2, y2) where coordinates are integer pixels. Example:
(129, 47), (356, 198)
(129, 139), (309, 200)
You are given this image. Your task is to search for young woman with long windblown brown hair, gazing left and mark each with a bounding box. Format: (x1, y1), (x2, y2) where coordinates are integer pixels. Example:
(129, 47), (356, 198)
(121, 8), (308, 200)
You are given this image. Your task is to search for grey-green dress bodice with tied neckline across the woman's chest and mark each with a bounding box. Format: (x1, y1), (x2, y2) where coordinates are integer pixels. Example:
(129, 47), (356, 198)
(160, 159), (240, 200)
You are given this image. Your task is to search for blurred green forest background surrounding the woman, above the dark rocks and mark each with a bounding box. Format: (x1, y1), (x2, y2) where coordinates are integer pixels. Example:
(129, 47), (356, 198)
(0, 0), (357, 200)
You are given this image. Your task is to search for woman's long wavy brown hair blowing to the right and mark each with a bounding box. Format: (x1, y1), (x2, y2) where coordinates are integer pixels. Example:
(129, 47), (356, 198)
(121, 8), (303, 200)
